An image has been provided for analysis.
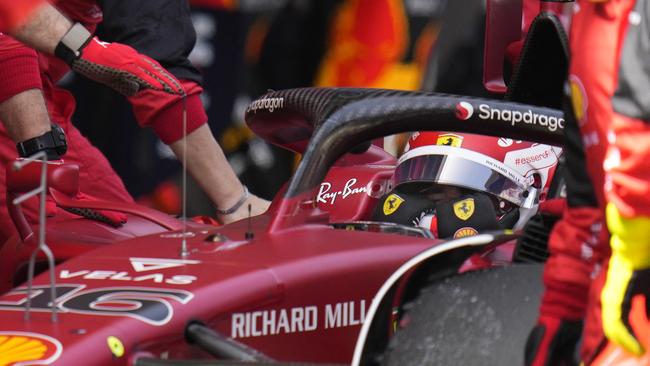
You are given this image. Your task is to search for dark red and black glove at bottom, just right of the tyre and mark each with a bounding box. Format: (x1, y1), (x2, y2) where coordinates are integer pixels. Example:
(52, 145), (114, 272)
(524, 316), (582, 366)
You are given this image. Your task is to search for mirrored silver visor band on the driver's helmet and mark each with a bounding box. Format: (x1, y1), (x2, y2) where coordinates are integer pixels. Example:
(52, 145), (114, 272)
(395, 155), (528, 207)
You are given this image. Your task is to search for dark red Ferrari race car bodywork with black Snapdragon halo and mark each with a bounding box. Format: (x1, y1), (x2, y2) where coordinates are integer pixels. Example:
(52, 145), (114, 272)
(0, 88), (563, 365)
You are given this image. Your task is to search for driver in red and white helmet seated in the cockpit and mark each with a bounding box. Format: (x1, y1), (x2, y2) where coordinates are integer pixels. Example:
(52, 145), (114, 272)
(372, 132), (562, 238)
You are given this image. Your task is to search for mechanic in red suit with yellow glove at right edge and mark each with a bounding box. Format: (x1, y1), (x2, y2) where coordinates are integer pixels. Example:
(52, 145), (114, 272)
(526, 0), (650, 365)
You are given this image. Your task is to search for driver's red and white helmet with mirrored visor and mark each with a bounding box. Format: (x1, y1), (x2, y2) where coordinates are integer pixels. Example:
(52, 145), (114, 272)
(395, 132), (562, 228)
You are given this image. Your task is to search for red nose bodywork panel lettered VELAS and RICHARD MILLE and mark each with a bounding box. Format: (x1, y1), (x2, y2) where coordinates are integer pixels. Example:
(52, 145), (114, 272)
(0, 217), (436, 365)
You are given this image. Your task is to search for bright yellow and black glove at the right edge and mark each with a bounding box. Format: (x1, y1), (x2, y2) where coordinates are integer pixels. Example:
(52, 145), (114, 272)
(600, 204), (650, 356)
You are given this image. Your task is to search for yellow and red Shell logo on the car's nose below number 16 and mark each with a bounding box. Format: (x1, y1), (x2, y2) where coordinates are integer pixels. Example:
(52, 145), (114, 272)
(0, 332), (63, 366)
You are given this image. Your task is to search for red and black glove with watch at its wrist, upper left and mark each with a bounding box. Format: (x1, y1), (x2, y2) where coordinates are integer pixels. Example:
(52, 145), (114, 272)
(55, 24), (185, 97)
